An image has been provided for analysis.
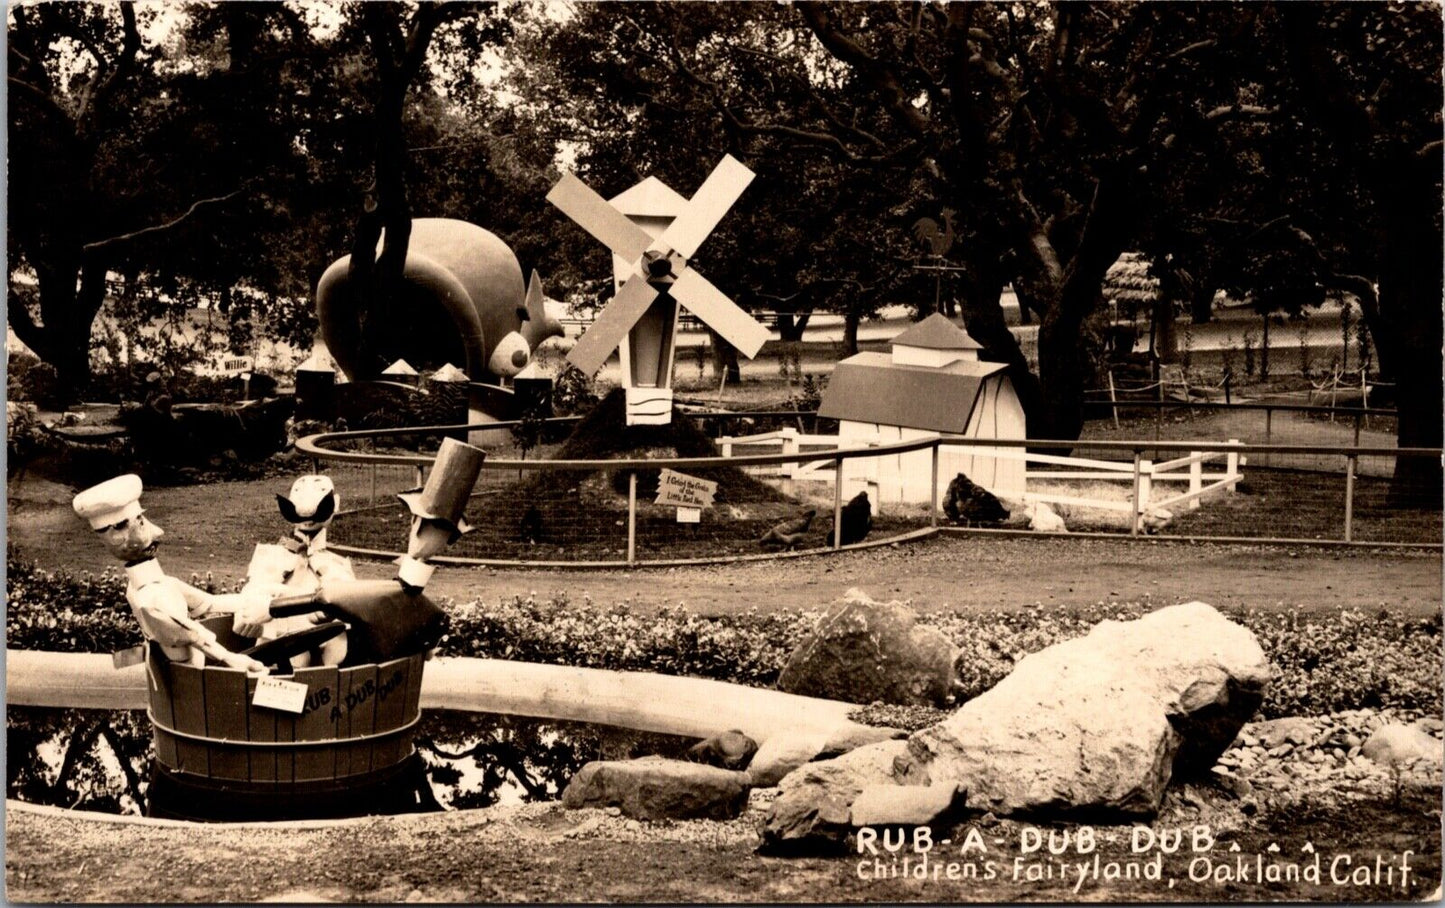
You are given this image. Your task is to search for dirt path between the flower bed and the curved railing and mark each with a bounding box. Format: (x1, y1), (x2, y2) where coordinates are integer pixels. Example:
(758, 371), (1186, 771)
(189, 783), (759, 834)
(7, 480), (1442, 614)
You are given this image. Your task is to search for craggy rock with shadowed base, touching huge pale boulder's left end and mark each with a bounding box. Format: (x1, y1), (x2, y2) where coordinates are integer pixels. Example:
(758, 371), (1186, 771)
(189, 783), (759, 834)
(754, 740), (907, 855)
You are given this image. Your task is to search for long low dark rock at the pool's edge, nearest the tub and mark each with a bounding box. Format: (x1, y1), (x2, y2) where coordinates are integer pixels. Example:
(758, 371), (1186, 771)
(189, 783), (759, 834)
(562, 756), (751, 820)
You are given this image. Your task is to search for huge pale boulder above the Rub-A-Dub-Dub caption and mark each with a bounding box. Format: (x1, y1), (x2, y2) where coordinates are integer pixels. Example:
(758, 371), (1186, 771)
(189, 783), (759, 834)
(903, 601), (1272, 815)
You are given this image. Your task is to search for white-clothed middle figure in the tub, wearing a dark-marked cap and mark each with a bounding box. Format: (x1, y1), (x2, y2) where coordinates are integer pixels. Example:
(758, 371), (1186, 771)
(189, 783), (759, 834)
(233, 473), (355, 668)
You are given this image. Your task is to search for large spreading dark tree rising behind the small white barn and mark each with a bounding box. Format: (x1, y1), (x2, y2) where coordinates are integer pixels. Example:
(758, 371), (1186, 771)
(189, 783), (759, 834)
(514, 3), (1283, 438)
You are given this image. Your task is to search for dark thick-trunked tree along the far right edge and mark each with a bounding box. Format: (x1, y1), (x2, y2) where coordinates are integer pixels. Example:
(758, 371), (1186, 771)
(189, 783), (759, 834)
(1279, 3), (1445, 505)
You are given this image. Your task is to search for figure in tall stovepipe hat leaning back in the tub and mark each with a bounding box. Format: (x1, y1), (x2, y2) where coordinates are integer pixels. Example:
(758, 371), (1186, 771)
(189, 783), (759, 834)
(236, 438), (487, 667)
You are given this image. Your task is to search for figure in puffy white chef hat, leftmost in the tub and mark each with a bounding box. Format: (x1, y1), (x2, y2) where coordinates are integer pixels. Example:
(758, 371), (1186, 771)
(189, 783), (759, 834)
(71, 473), (266, 672)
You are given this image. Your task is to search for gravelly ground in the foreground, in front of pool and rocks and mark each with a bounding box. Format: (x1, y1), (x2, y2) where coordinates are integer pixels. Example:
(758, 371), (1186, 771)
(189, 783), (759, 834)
(6, 710), (1441, 902)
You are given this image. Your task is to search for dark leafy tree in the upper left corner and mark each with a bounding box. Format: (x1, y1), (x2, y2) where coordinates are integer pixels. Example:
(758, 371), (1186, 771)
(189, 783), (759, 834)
(7, 3), (328, 395)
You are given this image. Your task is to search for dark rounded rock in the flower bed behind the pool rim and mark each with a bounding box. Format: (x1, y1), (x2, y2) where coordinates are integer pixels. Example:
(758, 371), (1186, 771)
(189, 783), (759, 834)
(777, 590), (957, 706)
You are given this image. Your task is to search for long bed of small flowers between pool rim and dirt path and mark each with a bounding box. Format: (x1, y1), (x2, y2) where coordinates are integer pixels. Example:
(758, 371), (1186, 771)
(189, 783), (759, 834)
(6, 557), (1442, 717)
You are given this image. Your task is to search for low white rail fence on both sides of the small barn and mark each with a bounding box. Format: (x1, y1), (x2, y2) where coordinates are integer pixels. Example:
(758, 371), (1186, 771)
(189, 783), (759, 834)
(717, 428), (1247, 532)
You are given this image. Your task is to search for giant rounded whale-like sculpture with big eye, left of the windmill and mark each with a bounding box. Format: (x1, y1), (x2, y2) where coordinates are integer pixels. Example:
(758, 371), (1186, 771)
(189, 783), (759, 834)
(316, 218), (562, 399)
